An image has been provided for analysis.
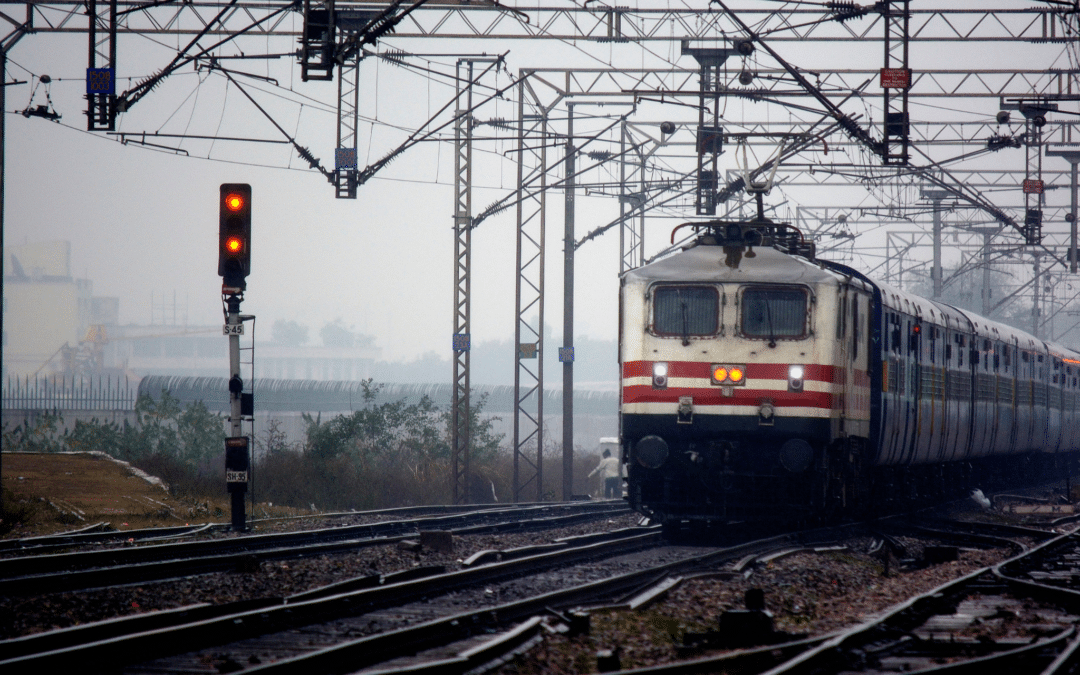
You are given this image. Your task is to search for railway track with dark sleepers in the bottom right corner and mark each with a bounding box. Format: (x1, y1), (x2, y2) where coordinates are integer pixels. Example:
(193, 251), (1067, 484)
(527, 522), (1067, 675)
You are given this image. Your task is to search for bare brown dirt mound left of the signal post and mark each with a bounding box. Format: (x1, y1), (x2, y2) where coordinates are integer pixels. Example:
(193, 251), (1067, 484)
(0, 453), (211, 538)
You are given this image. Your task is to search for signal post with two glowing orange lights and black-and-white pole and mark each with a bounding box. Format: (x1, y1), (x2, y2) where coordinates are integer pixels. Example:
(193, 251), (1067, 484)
(217, 183), (254, 531)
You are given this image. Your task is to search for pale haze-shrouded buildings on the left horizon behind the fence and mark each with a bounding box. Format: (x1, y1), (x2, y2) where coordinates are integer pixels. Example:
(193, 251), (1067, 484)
(0, 241), (380, 381)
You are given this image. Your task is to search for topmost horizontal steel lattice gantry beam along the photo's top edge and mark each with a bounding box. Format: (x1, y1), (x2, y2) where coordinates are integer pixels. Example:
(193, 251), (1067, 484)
(16, 0), (1076, 43)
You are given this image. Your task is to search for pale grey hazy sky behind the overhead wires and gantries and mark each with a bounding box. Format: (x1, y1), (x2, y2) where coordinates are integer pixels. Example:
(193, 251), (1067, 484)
(4, 0), (1076, 360)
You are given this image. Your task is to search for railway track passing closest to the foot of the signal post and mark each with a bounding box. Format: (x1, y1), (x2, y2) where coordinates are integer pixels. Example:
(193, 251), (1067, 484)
(0, 502), (629, 596)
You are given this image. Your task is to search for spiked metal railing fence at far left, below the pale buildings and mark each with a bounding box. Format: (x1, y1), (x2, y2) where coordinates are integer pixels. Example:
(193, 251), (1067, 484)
(2, 376), (139, 410)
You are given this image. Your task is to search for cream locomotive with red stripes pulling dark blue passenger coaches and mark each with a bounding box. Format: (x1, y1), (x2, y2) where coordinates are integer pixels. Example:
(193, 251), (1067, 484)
(619, 216), (1080, 531)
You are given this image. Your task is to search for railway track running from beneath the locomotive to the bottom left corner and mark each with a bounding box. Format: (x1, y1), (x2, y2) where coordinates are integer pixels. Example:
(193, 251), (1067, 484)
(0, 516), (864, 673)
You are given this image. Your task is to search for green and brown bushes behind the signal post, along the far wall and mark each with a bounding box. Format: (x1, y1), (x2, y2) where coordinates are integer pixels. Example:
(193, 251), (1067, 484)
(2, 380), (512, 510)
